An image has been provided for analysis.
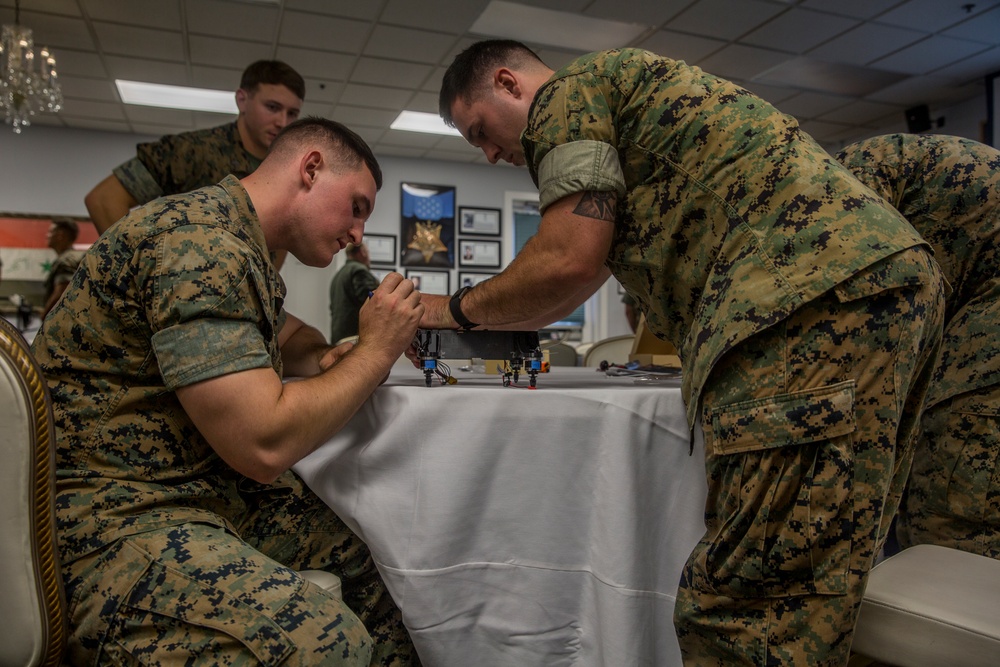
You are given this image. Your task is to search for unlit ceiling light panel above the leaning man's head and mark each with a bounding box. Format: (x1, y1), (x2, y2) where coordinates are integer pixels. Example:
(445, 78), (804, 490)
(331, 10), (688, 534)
(469, 0), (652, 51)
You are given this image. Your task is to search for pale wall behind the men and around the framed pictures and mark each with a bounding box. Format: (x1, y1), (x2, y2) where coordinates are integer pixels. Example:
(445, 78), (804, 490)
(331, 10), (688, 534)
(0, 125), (627, 338)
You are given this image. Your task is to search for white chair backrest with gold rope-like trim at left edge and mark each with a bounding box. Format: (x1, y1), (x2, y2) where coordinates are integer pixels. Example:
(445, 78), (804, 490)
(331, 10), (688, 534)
(0, 318), (66, 665)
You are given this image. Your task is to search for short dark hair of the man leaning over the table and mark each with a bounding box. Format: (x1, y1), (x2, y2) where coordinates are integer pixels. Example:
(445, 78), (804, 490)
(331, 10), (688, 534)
(438, 39), (545, 127)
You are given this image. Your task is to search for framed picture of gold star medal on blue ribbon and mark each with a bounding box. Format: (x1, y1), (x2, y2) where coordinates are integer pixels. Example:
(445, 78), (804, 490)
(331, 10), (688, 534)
(399, 183), (455, 269)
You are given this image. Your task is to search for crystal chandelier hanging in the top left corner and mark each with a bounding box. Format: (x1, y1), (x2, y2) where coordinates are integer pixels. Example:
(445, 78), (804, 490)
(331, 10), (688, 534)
(0, 0), (62, 134)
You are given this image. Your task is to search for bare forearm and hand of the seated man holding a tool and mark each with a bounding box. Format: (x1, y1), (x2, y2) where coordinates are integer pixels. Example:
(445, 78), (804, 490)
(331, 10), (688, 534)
(177, 274), (423, 483)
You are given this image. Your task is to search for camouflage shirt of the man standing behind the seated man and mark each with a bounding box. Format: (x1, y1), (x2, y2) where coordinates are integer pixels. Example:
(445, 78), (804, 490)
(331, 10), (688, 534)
(112, 121), (261, 204)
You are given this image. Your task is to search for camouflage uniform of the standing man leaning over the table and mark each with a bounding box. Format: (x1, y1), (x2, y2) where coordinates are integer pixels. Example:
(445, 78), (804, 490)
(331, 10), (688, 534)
(522, 50), (943, 667)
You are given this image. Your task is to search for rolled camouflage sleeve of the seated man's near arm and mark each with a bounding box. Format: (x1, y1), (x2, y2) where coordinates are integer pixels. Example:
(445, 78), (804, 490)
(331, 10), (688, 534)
(145, 225), (277, 390)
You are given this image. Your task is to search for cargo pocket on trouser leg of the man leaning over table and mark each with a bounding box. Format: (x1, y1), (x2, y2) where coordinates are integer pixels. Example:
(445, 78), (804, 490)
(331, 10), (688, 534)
(704, 380), (855, 598)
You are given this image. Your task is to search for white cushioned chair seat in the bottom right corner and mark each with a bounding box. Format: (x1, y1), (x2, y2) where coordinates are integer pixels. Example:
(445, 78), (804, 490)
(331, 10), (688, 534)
(851, 544), (1000, 667)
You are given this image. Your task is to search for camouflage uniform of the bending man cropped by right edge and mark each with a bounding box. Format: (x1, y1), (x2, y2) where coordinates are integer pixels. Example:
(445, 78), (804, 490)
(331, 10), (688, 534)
(837, 134), (1000, 558)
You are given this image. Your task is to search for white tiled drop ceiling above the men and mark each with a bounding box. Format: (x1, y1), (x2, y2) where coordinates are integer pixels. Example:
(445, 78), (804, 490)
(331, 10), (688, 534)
(0, 0), (1000, 162)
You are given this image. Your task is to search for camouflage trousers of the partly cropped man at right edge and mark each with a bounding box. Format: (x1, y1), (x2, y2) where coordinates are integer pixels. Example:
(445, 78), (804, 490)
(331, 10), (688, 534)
(896, 386), (1000, 558)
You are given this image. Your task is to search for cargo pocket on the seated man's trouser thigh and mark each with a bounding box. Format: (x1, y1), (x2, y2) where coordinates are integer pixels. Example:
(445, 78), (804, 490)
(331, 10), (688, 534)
(104, 542), (296, 665)
